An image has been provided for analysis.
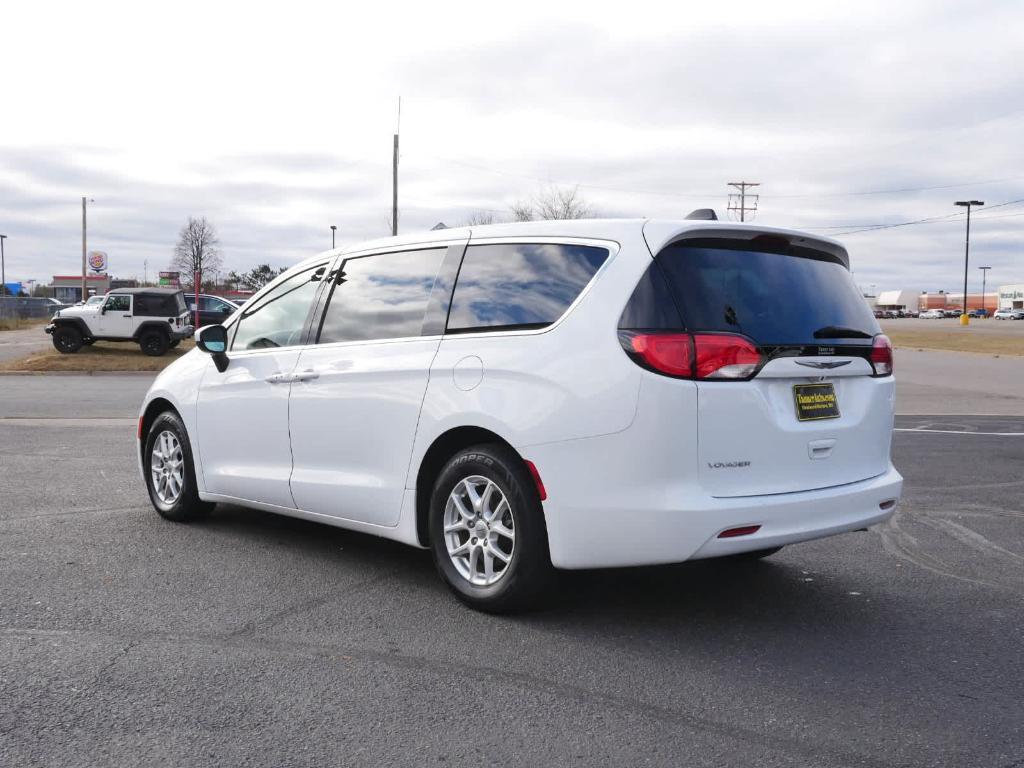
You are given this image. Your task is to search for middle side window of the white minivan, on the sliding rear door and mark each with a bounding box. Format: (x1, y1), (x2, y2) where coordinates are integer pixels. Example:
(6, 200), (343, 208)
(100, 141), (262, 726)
(319, 248), (445, 344)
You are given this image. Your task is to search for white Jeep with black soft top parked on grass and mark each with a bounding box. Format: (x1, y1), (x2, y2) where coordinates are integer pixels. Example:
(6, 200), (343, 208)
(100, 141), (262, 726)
(46, 288), (194, 356)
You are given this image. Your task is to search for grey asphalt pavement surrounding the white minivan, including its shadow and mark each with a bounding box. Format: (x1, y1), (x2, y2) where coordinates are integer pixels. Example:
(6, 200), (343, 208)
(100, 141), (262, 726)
(0, 376), (1024, 768)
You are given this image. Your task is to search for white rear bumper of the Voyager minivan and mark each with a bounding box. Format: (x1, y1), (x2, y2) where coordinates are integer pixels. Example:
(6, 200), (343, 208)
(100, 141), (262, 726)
(545, 466), (903, 568)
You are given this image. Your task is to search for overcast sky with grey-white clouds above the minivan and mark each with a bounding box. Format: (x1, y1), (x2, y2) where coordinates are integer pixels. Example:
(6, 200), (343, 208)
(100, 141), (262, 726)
(0, 0), (1024, 290)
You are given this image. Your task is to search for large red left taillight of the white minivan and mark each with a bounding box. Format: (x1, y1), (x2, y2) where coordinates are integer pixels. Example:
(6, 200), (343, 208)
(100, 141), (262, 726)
(620, 331), (761, 380)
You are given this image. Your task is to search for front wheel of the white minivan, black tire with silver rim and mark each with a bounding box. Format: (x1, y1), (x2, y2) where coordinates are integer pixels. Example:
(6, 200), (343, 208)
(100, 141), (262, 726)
(142, 411), (215, 522)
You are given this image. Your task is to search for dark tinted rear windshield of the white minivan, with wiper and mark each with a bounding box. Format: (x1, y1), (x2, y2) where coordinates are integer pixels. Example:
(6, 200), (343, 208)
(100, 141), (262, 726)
(657, 239), (881, 345)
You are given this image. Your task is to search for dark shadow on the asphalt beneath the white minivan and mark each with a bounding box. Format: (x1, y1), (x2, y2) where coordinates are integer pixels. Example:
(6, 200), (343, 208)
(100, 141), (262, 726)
(203, 505), (891, 634)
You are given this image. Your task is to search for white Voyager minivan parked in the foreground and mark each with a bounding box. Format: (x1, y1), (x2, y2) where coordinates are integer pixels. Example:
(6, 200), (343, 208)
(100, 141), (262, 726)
(138, 219), (902, 611)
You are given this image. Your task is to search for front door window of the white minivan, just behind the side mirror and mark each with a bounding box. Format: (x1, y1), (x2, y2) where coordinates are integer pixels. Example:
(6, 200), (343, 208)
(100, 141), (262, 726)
(231, 264), (327, 350)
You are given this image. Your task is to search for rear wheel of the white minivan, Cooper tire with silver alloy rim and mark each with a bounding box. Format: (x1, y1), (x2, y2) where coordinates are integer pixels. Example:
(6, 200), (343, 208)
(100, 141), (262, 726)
(428, 443), (553, 613)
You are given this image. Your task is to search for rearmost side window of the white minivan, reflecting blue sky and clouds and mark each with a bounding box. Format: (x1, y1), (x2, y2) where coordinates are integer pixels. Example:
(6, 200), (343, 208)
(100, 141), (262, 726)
(447, 243), (608, 333)
